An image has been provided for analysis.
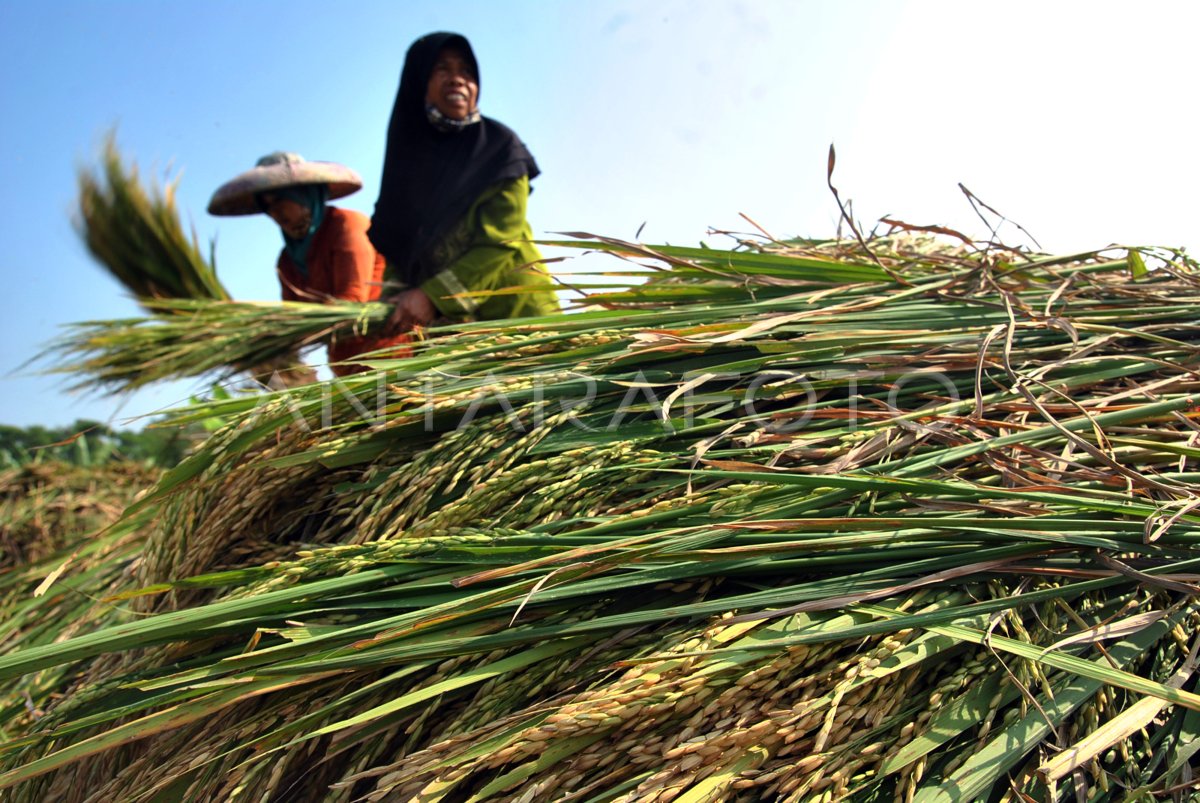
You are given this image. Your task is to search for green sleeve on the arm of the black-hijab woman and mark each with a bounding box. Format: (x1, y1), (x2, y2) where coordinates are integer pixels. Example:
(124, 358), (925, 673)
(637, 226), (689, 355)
(421, 175), (538, 318)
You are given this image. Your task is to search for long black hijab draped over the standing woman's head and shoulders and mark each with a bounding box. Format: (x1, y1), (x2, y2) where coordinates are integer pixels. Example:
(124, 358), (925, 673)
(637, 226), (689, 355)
(367, 32), (539, 286)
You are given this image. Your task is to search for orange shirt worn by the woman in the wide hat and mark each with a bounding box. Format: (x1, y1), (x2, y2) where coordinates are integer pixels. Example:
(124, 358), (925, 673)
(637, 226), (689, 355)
(276, 206), (409, 377)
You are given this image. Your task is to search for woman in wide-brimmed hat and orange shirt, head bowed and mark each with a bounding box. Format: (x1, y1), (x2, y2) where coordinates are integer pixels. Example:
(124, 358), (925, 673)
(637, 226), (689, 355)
(209, 151), (408, 376)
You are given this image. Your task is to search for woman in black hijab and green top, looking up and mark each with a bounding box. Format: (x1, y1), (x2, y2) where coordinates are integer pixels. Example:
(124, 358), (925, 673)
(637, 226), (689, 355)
(368, 32), (558, 330)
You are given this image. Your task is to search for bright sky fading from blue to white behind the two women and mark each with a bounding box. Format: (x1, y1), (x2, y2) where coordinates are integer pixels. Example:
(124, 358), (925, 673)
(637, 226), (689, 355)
(0, 0), (1200, 425)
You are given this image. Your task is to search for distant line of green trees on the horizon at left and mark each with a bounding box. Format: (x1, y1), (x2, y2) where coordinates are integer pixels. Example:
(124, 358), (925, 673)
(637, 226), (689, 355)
(0, 419), (196, 468)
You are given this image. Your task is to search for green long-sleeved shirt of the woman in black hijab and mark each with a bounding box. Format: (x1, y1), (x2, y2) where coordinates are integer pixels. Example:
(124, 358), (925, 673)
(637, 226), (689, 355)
(398, 175), (559, 320)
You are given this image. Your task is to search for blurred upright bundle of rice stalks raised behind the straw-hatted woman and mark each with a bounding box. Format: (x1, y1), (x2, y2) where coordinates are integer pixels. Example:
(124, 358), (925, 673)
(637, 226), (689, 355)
(77, 134), (229, 300)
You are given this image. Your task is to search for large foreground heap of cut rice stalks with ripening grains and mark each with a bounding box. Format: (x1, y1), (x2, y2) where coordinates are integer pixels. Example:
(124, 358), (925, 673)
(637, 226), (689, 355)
(0, 231), (1200, 802)
